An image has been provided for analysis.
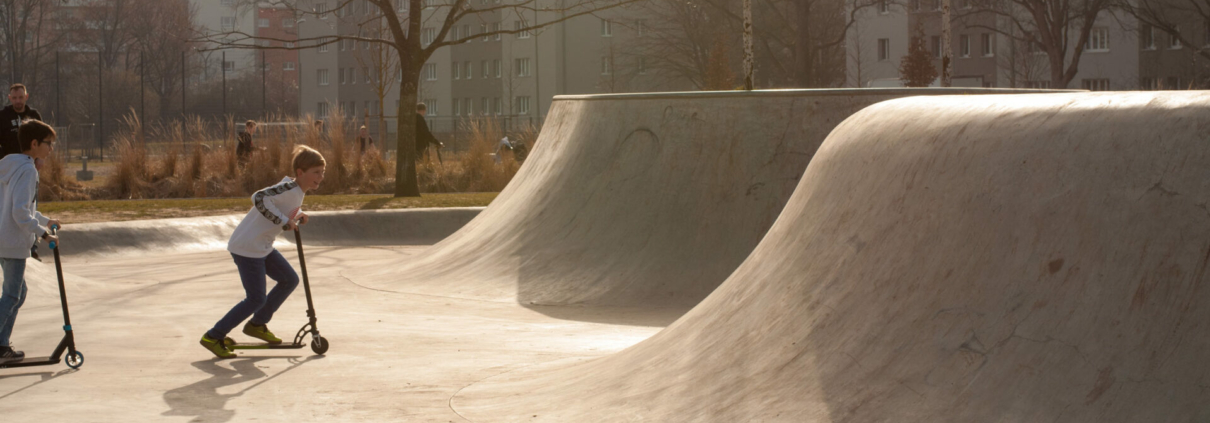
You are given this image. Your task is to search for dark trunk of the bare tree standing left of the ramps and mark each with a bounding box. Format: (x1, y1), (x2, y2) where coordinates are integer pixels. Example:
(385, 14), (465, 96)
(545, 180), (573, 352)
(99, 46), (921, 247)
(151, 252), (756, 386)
(394, 66), (420, 197)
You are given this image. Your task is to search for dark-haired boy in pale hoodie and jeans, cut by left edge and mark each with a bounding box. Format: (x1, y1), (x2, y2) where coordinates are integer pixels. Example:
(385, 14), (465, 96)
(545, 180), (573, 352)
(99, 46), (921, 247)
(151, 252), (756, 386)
(0, 121), (59, 361)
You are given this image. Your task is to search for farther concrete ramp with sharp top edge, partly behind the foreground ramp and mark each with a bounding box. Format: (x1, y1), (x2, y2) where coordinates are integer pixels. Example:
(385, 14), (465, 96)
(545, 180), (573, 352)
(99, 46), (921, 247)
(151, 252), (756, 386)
(355, 89), (1050, 307)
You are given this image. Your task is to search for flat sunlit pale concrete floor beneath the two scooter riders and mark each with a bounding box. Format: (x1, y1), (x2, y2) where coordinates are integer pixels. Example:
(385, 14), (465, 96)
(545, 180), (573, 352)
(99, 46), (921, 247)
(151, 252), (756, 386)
(0, 247), (684, 422)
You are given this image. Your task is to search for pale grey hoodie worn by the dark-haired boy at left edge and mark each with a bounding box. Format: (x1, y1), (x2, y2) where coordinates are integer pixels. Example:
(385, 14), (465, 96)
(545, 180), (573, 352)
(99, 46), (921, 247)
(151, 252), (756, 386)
(0, 153), (50, 259)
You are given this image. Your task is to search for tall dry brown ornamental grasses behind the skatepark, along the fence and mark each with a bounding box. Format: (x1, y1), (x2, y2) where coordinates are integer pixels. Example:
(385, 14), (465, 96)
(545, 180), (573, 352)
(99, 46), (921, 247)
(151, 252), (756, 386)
(42, 114), (527, 201)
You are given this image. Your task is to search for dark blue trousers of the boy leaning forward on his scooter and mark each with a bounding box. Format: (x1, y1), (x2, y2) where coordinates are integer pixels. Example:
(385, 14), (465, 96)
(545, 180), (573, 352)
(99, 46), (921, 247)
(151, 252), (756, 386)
(206, 249), (299, 340)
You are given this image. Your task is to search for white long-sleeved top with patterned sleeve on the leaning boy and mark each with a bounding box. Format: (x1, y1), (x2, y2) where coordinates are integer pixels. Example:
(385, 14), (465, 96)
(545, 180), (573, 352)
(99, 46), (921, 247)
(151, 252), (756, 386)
(227, 178), (305, 259)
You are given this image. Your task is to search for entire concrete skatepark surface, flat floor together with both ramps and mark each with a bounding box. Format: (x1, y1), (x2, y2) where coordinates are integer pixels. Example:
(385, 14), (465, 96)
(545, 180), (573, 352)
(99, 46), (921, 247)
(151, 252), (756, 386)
(0, 89), (1210, 422)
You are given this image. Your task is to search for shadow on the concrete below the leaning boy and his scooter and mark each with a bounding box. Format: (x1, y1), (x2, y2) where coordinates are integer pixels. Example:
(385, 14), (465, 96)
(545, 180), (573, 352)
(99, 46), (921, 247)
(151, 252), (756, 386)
(161, 355), (322, 423)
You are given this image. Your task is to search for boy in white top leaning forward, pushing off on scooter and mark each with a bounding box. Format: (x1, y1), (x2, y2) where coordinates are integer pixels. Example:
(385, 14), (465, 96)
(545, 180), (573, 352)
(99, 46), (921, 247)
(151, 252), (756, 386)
(201, 145), (325, 359)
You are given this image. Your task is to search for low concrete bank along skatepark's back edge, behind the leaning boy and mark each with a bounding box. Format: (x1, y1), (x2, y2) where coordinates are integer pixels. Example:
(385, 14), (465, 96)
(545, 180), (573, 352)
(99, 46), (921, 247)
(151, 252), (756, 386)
(61, 207), (483, 256)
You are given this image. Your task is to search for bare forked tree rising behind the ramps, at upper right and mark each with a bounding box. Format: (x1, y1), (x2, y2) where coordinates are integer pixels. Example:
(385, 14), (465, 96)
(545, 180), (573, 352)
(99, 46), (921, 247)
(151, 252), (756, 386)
(967, 0), (1113, 88)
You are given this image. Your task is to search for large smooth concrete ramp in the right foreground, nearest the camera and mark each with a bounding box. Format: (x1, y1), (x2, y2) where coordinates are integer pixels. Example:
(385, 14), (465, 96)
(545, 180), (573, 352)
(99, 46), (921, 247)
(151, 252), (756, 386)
(451, 92), (1210, 422)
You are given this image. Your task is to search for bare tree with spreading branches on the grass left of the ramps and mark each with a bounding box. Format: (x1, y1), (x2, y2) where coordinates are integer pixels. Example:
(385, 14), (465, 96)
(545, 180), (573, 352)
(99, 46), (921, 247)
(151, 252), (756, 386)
(203, 0), (645, 197)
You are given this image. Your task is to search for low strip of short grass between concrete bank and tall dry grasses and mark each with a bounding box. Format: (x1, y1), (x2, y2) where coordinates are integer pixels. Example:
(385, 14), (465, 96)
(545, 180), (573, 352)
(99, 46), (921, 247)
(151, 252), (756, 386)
(38, 192), (499, 224)
